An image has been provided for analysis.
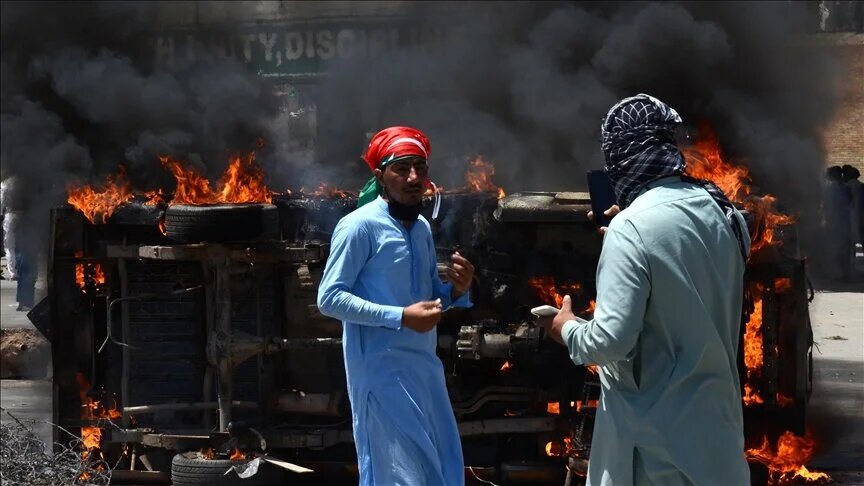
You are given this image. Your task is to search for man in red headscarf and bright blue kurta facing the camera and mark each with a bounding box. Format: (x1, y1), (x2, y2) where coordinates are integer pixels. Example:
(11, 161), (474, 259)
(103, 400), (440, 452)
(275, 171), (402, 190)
(318, 127), (474, 485)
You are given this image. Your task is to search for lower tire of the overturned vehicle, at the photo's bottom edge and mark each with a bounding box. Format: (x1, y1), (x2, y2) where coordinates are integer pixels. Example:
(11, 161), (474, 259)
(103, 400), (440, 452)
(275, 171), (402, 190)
(171, 451), (287, 486)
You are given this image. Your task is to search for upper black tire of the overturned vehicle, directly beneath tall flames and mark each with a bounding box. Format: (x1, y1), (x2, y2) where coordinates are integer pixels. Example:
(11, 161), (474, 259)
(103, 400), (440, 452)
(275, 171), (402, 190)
(165, 204), (279, 243)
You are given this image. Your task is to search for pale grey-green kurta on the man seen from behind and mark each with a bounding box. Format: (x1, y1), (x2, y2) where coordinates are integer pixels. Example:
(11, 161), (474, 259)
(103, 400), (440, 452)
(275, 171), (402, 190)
(562, 177), (750, 486)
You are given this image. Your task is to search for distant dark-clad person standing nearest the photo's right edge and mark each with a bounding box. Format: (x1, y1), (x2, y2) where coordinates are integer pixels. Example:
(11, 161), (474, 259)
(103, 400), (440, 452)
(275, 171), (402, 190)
(822, 165), (852, 279)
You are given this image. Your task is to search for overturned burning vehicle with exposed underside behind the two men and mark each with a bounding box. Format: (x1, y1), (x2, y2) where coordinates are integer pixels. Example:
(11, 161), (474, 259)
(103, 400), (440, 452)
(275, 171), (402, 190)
(31, 127), (824, 485)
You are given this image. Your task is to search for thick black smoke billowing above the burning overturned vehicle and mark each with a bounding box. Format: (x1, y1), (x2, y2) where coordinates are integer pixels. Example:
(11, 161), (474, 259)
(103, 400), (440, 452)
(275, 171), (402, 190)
(0, 2), (838, 262)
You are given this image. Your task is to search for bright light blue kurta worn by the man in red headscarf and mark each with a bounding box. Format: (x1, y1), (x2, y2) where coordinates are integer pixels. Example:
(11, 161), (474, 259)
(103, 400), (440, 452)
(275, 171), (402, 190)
(318, 197), (471, 485)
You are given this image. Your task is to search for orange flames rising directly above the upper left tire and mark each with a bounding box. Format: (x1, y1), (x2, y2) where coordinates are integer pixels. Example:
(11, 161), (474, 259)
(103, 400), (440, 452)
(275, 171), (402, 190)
(159, 148), (272, 205)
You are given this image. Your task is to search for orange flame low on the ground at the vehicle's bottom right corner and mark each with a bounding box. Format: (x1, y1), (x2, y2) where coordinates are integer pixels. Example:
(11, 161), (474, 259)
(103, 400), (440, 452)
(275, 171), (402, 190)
(747, 431), (830, 484)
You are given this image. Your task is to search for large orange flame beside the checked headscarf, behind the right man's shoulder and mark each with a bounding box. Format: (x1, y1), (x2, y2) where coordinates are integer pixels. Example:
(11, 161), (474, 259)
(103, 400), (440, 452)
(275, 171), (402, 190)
(682, 123), (795, 253)
